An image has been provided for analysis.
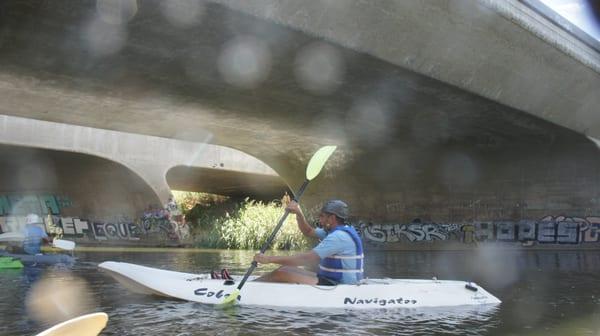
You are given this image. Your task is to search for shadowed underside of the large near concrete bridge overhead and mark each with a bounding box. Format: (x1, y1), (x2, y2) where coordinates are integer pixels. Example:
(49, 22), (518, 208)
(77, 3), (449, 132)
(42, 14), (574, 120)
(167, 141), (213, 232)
(0, 1), (580, 152)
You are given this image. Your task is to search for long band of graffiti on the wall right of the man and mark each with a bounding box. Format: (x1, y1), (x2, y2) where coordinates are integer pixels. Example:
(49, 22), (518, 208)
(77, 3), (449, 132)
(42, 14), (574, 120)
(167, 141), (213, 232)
(356, 216), (600, 244)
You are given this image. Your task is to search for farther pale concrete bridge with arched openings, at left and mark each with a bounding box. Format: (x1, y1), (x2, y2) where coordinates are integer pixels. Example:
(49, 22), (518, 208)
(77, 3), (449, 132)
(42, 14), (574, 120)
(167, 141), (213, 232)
(0, 116), (287, 219)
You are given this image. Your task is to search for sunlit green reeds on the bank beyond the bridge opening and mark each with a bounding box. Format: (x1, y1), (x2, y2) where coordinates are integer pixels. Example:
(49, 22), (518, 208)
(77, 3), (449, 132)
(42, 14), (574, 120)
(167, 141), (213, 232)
(173, 192), (309, 250)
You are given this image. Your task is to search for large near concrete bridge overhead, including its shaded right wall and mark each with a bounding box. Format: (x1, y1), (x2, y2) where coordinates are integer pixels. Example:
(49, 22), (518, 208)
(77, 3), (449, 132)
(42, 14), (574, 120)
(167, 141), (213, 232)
(0, 0), (600, 247)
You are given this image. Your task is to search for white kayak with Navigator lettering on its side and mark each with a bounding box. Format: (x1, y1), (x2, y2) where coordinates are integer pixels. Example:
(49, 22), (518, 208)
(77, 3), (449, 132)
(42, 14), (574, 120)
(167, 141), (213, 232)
(98, 261), (500, 309)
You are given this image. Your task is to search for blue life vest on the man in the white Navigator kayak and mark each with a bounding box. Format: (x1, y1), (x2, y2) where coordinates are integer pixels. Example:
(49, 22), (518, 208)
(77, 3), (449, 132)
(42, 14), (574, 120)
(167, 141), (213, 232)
(317, 225), (364, 283)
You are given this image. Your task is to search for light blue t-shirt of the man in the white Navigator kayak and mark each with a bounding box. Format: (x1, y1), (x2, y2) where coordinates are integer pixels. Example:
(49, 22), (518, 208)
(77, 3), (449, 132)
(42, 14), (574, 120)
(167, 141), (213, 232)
(313, 228), (360, 284)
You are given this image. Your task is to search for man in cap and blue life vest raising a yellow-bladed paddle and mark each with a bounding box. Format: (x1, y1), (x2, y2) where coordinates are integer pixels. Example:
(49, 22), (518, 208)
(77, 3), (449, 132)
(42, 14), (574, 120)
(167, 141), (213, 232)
(254, 200), (364, 285)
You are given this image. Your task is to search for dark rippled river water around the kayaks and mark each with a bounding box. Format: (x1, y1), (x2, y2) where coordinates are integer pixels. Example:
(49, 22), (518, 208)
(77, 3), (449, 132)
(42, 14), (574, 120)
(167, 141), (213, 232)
(0, 247), (600, 336)
